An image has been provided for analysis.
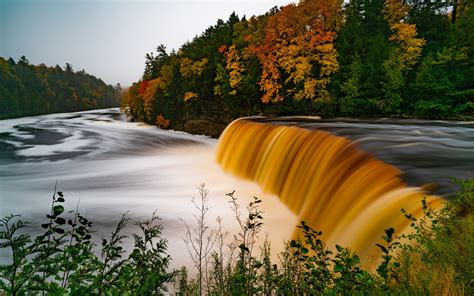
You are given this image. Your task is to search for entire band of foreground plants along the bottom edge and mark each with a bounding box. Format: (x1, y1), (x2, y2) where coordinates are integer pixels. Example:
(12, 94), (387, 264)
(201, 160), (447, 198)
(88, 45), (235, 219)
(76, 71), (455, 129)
(0, 179), (474, 295)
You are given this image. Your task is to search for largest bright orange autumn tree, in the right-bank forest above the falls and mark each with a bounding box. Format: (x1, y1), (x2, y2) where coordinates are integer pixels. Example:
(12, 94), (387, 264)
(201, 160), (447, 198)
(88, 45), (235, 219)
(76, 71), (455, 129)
(249, 0), (341, 103)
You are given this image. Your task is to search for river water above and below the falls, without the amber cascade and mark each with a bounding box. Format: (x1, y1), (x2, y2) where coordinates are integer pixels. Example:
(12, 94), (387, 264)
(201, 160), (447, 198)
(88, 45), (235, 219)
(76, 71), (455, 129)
(0, 109), (474, 267)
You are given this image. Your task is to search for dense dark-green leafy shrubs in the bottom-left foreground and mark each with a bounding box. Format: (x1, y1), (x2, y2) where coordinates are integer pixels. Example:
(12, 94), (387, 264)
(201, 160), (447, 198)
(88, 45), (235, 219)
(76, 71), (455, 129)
(0, 188), (175, 295)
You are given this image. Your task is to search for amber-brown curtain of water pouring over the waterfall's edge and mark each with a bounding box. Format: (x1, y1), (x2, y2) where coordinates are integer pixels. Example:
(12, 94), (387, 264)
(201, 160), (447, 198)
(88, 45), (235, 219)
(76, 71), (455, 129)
(216, 119), (443, 264)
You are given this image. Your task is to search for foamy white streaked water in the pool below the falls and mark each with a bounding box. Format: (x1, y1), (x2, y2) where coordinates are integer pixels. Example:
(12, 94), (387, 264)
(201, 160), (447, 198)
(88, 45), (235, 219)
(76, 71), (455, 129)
(0, 109), (296, 267)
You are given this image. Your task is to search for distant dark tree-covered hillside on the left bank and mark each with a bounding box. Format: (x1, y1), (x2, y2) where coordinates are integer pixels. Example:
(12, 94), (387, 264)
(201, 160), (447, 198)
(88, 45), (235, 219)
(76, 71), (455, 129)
(0, 56), (121, 119)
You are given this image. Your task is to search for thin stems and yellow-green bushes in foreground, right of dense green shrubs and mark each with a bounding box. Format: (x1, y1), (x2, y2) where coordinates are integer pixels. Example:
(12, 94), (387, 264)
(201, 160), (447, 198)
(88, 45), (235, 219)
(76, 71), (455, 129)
(176, 179), (474, 295)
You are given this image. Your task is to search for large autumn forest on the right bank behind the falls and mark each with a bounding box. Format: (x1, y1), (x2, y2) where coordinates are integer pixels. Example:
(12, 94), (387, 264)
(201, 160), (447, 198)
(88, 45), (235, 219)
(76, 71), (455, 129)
(123, 0), (474, 135)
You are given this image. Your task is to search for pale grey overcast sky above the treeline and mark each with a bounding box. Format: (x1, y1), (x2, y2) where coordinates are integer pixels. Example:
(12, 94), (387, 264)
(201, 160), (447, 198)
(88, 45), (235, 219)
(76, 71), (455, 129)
(0, 0), (294, 86)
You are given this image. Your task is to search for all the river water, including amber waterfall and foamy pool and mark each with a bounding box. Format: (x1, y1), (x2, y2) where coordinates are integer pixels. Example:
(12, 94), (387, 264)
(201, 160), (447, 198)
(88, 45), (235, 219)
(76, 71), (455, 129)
(0, 109), (474, 267)
